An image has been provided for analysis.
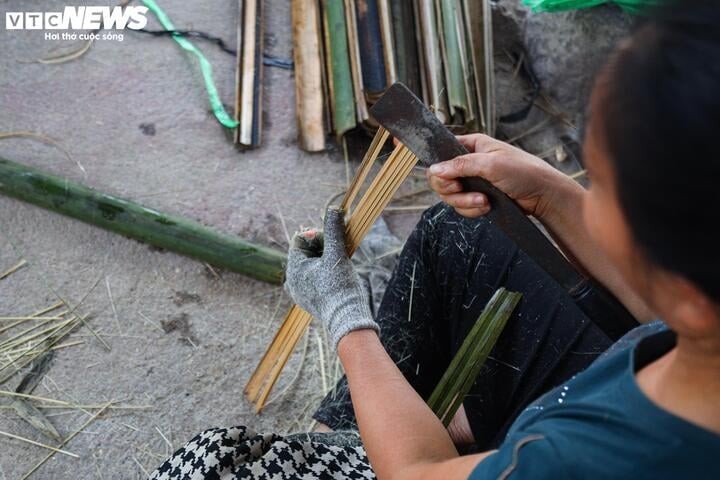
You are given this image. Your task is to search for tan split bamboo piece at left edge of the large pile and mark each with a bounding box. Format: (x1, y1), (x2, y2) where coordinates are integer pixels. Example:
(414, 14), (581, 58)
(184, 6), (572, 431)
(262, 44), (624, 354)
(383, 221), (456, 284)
(292, 0), (325, 152)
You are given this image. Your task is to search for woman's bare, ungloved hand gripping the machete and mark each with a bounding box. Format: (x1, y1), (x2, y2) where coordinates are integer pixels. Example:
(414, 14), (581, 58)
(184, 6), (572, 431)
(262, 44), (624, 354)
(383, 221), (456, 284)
(427, 133), (569, 219)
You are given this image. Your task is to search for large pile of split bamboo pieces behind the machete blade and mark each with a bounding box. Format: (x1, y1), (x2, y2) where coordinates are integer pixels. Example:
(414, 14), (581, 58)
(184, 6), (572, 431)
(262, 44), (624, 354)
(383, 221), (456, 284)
(292, 0), (495, 151)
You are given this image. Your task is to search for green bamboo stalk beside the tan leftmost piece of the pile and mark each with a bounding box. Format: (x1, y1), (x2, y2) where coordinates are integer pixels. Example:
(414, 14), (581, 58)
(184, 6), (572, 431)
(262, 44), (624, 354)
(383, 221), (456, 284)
(323, 0), (357, 140)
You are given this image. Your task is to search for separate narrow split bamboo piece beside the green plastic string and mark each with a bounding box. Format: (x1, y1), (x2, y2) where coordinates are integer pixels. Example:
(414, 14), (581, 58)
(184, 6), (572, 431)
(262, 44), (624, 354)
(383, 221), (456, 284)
(235, 0), (264, 148)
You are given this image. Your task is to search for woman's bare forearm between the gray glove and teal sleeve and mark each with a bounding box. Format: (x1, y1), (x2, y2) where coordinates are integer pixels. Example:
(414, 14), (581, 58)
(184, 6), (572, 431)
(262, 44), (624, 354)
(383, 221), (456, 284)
(338, 330), (492, 480)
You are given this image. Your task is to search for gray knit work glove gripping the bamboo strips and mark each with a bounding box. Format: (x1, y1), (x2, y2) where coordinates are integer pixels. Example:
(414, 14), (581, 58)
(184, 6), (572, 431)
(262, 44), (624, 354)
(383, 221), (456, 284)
(285, 208), (379, 348)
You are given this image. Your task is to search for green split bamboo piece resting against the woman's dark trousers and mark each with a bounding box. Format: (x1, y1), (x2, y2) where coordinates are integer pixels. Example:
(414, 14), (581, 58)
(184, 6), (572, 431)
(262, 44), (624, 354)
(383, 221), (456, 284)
(428, 288), (522, 426)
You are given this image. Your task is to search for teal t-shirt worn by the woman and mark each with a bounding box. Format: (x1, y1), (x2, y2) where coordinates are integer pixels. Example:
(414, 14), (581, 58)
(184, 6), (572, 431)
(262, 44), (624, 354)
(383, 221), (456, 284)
(470, 322), (720, 480)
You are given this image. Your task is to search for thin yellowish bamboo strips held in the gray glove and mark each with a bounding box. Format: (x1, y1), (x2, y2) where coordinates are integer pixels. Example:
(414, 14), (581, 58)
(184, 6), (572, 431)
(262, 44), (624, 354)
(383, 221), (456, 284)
(245, 128), (417, 412)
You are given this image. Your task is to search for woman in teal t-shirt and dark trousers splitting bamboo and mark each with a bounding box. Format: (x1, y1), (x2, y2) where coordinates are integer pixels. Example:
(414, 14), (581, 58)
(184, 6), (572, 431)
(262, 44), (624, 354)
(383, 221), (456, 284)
(150, 1), (720, 480)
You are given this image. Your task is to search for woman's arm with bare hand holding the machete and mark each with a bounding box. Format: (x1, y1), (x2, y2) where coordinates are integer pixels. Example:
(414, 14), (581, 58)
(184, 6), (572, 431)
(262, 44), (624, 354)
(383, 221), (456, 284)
(428, 134), (653, 321)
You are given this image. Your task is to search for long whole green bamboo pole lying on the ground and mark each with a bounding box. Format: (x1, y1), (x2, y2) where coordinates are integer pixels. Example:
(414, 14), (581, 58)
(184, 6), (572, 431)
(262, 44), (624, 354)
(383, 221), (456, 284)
(0, 158), (285, 284)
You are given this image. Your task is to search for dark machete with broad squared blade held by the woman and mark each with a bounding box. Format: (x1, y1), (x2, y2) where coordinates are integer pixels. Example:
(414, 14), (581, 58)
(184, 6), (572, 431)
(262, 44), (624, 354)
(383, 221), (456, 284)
(370, 83), (638, 340)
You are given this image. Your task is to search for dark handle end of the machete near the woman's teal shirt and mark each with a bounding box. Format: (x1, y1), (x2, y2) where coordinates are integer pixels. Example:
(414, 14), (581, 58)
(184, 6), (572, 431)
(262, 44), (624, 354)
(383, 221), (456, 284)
(568, 279), (639, 342)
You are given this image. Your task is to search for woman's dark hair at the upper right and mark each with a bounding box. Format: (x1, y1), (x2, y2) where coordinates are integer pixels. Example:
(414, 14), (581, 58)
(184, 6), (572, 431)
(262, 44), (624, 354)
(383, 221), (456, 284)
(594, 0), (720, 301)
